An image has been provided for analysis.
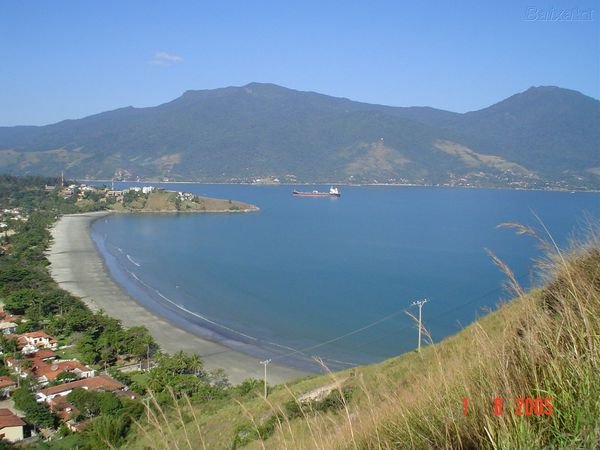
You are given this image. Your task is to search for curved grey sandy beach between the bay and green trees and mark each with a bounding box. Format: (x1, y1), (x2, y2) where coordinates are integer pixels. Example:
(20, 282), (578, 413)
(48, 212), (306, 384)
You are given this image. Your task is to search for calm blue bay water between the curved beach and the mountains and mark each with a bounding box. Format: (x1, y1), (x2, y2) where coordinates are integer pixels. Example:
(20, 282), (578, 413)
(93, 183), (600, 368)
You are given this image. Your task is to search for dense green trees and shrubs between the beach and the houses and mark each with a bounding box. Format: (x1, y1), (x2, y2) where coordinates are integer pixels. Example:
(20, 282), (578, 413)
(0, 176), (255, 449)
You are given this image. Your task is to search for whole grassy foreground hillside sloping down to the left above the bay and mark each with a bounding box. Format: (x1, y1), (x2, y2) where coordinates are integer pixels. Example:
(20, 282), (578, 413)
(127, 234), (600, 449)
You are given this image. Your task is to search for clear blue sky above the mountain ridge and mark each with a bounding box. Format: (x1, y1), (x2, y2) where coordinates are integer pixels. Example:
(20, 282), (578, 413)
(0, 0), (600, 125)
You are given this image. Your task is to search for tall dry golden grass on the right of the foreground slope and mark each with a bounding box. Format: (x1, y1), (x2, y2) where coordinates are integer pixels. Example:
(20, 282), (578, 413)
(324, 228), (600, 448)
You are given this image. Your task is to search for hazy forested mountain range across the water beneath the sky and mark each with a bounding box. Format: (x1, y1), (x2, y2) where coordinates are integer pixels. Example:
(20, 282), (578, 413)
(0, 83), (600, 188)
